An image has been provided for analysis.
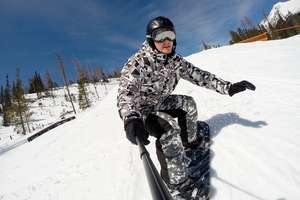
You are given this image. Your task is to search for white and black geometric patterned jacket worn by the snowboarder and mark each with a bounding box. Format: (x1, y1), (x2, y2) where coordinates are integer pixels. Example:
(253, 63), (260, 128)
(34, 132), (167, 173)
(117, 42), (231, 120)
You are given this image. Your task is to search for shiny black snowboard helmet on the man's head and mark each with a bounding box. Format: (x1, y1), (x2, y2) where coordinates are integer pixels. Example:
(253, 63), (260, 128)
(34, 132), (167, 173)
(146, 16), (176, 52)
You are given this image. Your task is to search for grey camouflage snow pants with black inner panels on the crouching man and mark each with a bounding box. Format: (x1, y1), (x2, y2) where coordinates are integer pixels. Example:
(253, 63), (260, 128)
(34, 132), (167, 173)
(145, 95), (198, 185)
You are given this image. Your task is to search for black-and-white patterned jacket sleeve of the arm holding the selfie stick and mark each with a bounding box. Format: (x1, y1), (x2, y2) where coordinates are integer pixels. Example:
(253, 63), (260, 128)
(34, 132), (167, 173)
(117, 58), (141, 121)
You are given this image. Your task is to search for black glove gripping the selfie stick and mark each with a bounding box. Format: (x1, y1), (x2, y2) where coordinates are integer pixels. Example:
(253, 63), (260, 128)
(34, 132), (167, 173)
(125, 118), (150, 145)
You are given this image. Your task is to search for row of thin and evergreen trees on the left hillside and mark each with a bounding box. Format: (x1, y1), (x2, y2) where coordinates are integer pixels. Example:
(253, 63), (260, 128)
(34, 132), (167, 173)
(0, 55), (120, 134)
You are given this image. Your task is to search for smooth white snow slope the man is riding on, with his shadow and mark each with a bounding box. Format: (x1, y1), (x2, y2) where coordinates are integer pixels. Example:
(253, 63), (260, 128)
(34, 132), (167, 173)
(0, 35), (300, 200)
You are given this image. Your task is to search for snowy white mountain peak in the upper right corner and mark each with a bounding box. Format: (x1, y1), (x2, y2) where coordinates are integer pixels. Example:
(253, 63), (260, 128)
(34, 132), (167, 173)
(261, 0), (300, 27)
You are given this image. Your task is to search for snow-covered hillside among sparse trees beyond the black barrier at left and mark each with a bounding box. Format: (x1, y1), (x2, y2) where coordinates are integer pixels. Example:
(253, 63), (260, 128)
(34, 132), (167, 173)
(0, 79), (118, 153)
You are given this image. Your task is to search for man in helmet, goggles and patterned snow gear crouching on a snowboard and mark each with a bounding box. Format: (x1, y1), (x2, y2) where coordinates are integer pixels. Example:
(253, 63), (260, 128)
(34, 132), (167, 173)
(117, 16), (255, 199)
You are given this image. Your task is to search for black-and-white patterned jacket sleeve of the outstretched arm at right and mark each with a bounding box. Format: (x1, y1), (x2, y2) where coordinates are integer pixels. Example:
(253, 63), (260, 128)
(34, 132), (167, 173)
(179, 57), (231, 94)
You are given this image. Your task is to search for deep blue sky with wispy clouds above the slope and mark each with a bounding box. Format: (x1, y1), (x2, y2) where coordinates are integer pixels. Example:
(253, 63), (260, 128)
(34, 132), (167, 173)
(0, 0), (279, 88)
